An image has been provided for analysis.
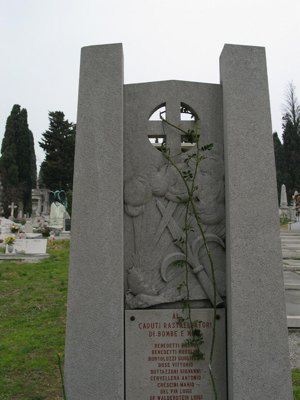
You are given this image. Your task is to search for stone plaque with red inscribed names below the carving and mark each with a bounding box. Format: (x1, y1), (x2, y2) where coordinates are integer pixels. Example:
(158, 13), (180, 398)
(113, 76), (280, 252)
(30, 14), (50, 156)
(125, 309), (227, 400)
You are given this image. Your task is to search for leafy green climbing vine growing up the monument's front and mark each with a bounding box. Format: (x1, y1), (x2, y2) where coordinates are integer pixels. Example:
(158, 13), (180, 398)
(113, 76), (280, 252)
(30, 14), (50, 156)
(160, 115), (218, 400)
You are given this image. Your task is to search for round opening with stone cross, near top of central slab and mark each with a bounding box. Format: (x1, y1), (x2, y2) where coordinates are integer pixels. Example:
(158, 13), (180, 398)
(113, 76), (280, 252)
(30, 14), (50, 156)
(148, 101), (198, 155)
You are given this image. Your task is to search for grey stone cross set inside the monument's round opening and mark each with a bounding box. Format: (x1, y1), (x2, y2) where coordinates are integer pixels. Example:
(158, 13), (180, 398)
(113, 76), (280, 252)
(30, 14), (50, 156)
(148, 98), (195, 156)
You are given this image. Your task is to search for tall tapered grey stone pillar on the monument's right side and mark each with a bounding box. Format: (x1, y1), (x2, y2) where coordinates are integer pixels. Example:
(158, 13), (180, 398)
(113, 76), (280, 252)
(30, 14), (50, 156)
(220, 45), (292, 400)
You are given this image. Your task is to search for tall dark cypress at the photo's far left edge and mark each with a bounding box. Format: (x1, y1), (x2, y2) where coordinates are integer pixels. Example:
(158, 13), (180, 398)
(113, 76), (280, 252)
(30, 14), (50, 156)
(0, 104), (36, 215)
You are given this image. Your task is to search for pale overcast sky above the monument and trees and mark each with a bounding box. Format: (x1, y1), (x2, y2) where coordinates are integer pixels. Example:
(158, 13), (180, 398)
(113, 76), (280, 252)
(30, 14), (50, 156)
(0, 0), (300, 164)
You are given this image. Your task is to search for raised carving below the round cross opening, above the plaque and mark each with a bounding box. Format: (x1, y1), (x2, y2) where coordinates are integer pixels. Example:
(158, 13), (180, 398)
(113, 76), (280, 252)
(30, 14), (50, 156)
(124, 115), (225, 308)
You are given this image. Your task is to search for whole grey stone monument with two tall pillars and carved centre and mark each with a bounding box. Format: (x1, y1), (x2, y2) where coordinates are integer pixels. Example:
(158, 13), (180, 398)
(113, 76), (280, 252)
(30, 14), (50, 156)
(65, 44), (292, 400)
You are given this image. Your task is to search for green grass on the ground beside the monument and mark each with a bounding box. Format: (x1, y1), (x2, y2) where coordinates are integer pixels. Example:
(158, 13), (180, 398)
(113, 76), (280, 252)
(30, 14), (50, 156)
(0, 241), (300, 400)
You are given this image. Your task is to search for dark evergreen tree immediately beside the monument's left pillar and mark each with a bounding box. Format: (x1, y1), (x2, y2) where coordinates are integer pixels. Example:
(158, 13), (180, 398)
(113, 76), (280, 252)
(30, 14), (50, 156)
(39, 111), (76, 192)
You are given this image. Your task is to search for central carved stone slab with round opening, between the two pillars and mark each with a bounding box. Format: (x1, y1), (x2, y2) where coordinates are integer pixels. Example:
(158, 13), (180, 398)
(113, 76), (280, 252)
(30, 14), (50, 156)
(124, 81), (226, 309)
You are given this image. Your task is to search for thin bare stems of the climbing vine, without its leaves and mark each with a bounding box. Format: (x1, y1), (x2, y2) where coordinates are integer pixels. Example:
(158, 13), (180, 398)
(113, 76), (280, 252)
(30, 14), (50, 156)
(161, 118), (218, 400)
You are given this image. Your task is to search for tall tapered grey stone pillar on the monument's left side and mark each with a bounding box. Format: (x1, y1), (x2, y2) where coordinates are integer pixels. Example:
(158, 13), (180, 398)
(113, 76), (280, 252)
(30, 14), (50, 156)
(65, 44), (124, 400)
